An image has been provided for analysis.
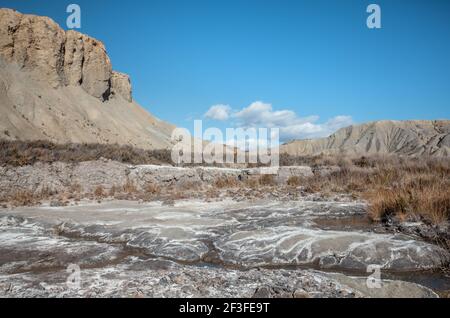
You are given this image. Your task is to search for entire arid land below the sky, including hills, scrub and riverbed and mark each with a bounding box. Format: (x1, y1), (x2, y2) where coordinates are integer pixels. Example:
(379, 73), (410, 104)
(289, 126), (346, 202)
(0, 9), (450, 298)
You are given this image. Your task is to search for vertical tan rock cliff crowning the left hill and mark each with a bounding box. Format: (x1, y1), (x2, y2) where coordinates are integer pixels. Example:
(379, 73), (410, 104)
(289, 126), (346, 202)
(0, 9), (131, 102)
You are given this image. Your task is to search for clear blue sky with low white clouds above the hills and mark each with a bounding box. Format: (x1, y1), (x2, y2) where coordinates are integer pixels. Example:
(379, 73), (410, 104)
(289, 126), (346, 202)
(0, 0), (450, 138)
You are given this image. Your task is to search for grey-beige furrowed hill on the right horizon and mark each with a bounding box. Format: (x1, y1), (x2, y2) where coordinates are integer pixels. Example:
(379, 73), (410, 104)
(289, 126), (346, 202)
(280, 120), (450, 157)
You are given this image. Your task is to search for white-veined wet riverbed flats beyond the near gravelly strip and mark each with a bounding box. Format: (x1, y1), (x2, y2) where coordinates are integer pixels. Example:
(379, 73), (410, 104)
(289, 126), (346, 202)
(0, 200), (450, 291)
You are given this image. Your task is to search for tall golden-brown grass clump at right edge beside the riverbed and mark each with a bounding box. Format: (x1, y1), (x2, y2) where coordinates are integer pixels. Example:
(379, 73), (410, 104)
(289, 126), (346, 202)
(364, 159), (450, 223)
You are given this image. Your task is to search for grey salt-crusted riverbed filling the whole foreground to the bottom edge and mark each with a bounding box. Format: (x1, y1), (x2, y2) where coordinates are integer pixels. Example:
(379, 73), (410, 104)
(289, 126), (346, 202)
(0, 198), (450, 297)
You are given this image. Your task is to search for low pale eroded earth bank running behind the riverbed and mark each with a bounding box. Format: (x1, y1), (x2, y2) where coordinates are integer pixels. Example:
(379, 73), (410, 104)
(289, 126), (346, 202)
(0, 159), (313, 195)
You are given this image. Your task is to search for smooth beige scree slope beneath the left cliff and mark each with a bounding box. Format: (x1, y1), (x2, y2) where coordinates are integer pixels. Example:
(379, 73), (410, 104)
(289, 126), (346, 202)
(0, 62), (174, 149)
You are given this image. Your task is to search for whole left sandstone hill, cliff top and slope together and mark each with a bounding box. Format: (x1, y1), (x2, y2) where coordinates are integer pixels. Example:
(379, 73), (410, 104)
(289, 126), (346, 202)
(0, 9), (175, 149)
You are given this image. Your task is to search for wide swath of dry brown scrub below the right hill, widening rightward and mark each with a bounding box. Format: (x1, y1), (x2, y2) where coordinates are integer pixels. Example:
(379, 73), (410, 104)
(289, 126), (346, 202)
(296, 157), (450, 223)
